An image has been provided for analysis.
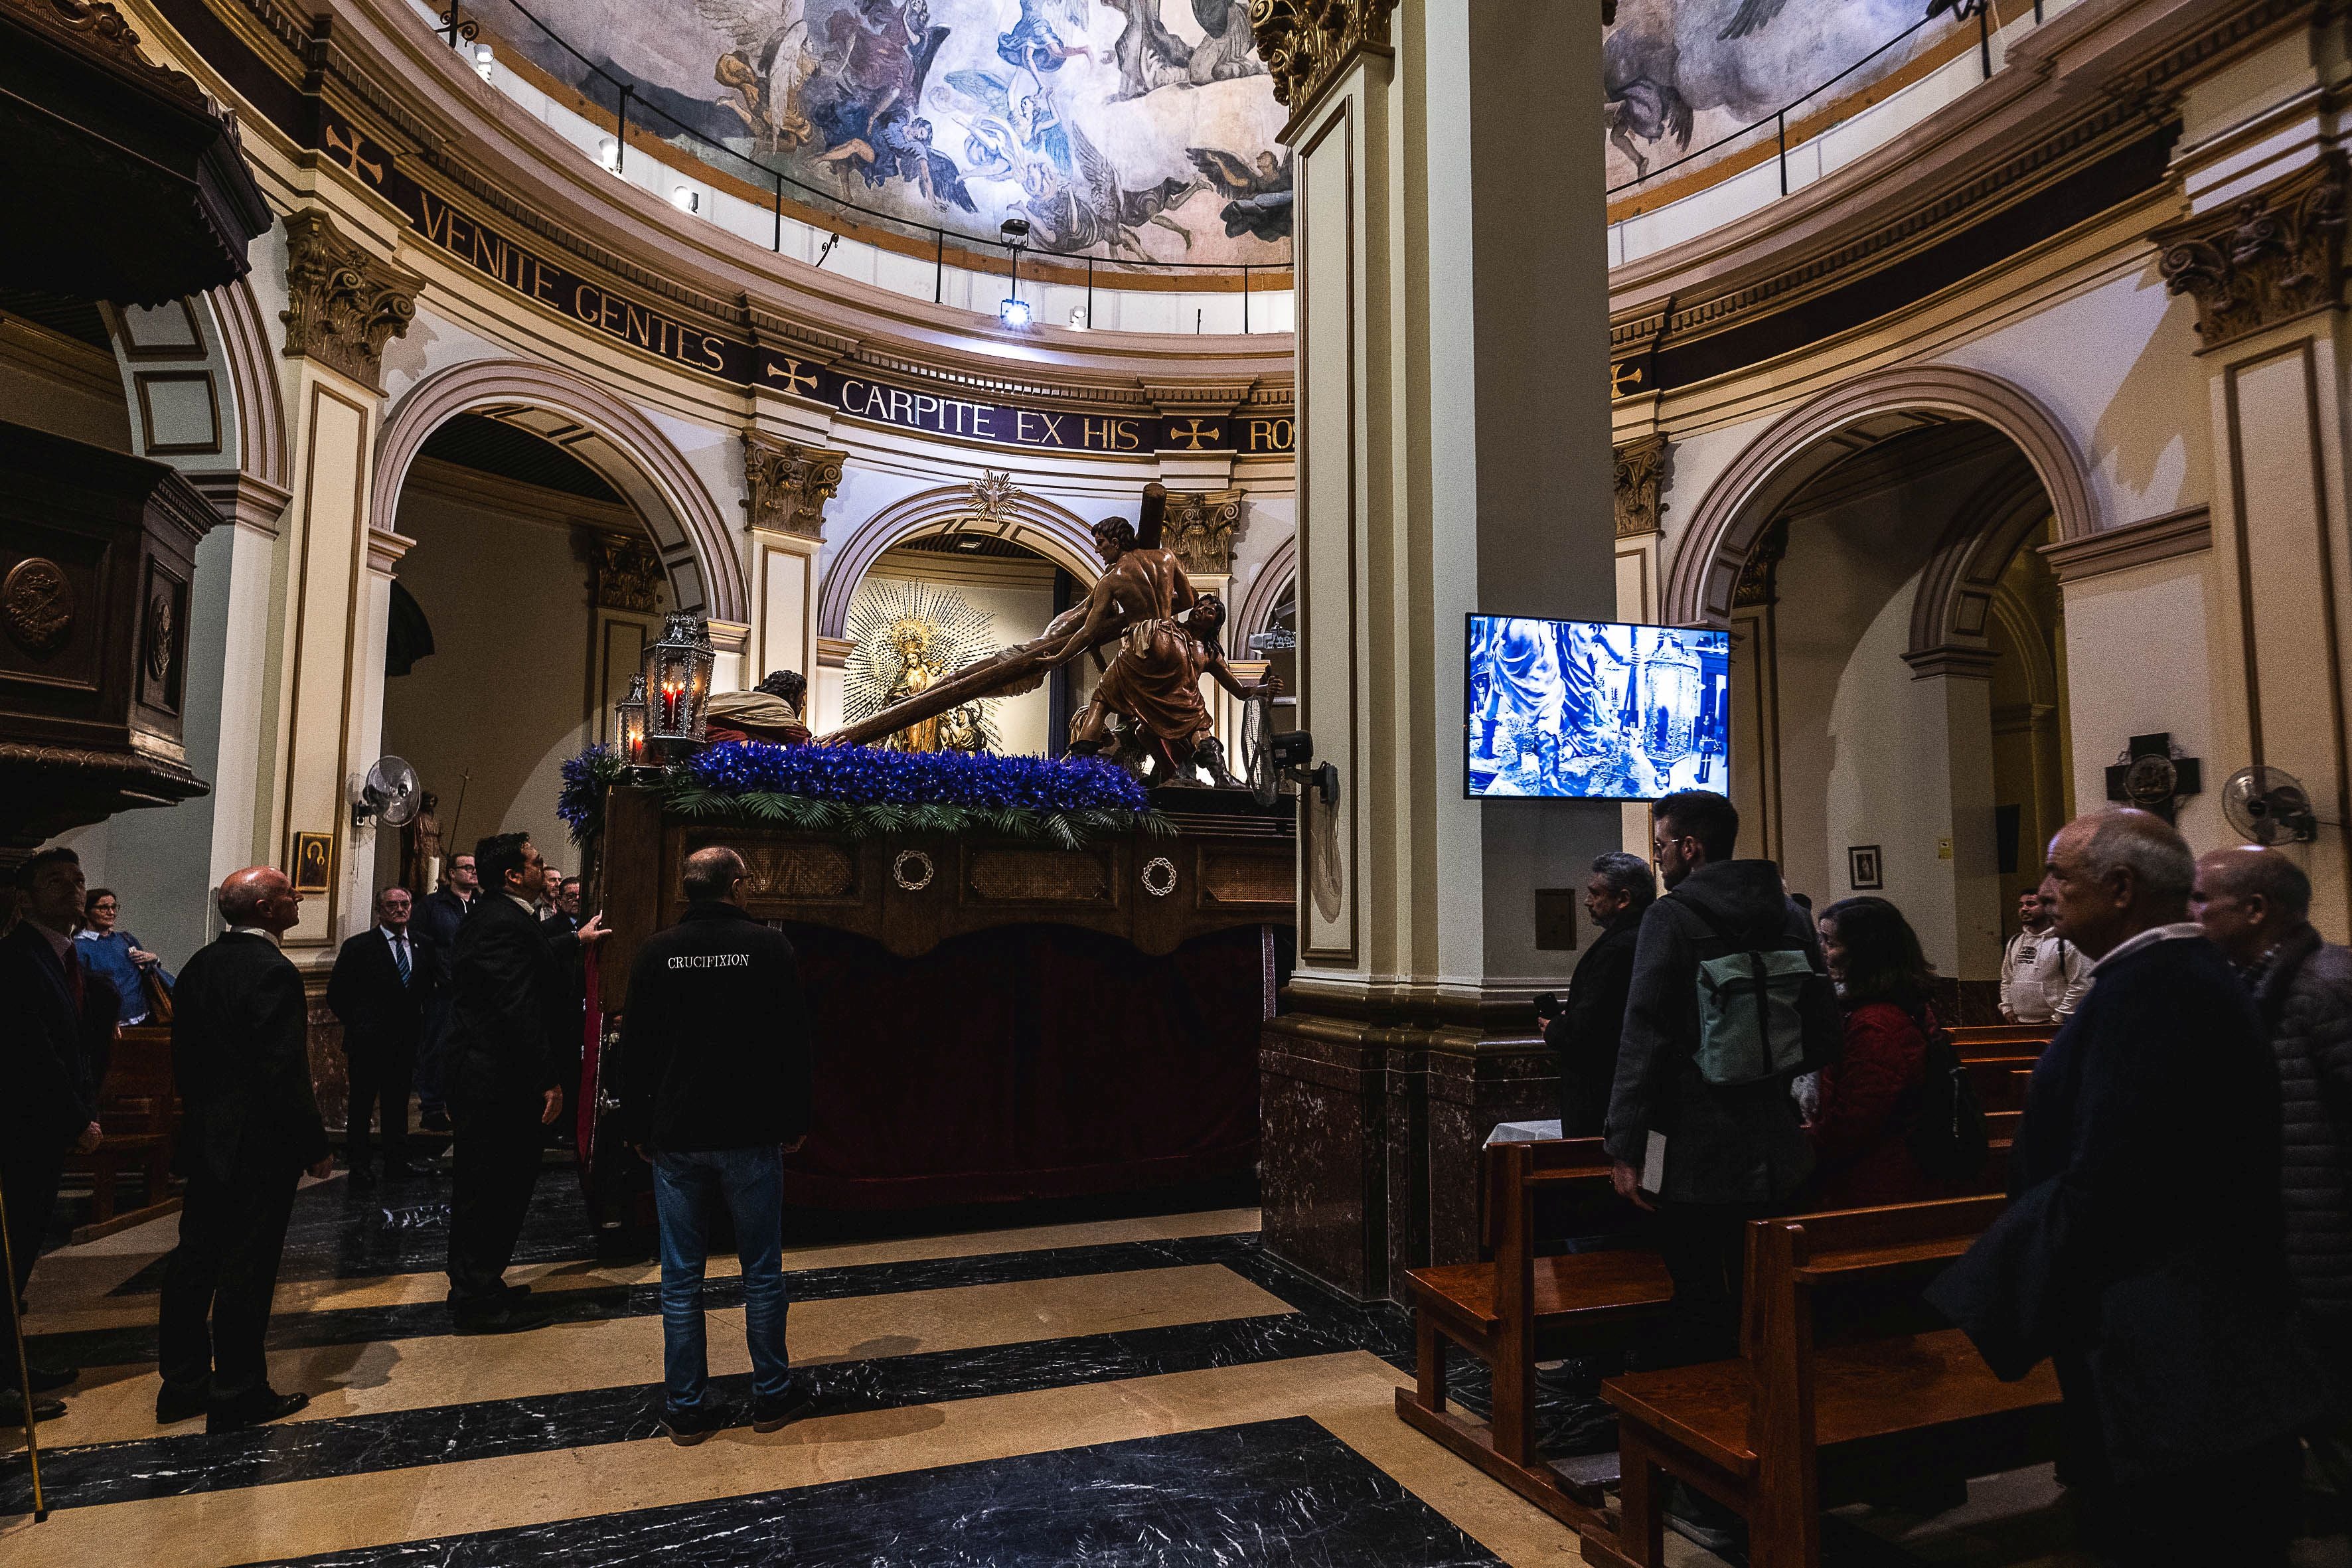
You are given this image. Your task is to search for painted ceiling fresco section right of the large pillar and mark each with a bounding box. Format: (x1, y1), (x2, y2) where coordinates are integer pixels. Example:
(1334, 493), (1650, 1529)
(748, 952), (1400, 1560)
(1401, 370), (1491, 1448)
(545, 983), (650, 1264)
(1602, 0), (1938, 197)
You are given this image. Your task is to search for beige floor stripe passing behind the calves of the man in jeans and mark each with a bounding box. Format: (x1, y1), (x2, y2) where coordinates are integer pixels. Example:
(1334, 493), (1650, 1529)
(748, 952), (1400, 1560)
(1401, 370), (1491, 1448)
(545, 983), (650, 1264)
(40, 1263), (1291, 1448)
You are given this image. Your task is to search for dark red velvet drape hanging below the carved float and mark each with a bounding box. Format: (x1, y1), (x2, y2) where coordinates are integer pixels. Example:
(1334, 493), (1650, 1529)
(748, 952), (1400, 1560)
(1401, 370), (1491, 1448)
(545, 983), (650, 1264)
(785, 926), (1268, 1208)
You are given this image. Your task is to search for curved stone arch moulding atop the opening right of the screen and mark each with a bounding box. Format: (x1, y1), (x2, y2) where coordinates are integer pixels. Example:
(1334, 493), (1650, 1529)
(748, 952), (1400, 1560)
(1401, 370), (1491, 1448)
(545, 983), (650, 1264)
(1660, 364), (2100, 625)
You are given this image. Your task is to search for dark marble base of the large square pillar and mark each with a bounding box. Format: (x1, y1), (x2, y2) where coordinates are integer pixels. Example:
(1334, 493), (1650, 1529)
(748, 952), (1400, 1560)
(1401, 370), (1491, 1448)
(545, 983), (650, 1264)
(1259, 996), (1559, 1300)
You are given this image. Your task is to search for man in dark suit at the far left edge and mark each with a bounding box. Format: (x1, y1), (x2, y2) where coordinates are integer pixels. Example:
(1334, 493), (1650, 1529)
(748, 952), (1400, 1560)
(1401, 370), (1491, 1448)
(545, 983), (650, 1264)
(0, 848), (101, 1427)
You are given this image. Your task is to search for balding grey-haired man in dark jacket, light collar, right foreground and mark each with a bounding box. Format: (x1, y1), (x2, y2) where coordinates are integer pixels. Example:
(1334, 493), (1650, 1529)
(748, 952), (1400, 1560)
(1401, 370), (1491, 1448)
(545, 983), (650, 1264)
(1928, 811), (2321, 1568)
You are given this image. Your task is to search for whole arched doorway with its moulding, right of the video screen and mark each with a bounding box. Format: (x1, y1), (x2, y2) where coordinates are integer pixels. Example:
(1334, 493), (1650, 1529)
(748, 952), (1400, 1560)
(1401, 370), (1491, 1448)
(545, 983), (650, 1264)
(1665, 372), (2088, 1018)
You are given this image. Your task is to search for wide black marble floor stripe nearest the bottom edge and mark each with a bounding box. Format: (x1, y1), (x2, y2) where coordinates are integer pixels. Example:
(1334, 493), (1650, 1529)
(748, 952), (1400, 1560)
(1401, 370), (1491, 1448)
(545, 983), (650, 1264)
(229, 1417), (1500, 1568)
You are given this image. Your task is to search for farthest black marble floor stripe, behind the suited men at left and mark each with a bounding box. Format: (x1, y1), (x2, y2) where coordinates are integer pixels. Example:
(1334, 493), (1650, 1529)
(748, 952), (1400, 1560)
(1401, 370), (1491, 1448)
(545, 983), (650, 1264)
(111, 1164), (595, 1295)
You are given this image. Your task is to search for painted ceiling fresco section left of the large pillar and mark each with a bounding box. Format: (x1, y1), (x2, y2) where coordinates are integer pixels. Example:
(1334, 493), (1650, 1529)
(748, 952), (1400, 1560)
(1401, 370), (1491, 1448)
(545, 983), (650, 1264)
(503, 0), (1291, 264)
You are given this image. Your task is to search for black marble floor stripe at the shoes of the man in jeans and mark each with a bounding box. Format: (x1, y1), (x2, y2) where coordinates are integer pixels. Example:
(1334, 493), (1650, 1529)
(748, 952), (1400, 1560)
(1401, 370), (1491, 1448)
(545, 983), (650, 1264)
(0, 1239), (1411, 1514)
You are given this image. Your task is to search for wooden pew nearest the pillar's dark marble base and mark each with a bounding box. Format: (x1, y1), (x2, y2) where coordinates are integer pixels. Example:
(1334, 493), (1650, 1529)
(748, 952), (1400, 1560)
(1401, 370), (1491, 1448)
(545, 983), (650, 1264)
(1397, 1138), (1675, 1530)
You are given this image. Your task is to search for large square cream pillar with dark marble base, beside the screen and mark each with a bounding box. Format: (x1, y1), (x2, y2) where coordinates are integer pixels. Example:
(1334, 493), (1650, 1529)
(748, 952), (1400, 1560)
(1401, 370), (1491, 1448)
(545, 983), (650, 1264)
(1259, 0), (1623, 1295)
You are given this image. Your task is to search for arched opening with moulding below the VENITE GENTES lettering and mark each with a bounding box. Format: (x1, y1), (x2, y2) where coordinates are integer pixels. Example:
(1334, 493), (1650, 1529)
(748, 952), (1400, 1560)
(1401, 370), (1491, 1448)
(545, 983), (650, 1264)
(374, 362), (745, 894)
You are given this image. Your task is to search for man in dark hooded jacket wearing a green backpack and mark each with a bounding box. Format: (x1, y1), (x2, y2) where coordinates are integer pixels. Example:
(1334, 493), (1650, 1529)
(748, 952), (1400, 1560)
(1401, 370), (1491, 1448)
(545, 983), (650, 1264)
(1607, 790), (1844, 1439)
